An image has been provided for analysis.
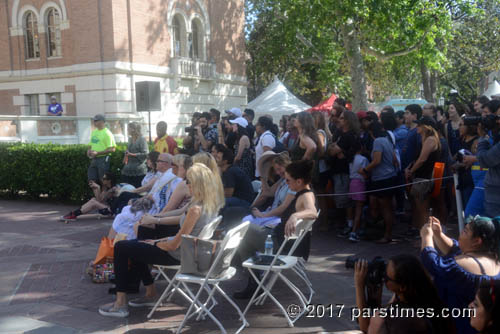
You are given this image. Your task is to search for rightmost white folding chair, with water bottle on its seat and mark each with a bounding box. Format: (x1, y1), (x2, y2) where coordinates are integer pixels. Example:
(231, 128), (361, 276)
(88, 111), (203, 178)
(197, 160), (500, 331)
(243, 218), (316, 327)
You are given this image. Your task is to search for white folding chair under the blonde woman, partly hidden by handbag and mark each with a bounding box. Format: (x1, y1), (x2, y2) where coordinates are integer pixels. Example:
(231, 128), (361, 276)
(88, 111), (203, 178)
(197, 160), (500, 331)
(148, 216), (222, 319)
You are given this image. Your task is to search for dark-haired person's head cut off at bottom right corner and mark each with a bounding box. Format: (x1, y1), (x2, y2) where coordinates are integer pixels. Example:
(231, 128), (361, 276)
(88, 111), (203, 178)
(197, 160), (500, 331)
(469, 279), (500, 334)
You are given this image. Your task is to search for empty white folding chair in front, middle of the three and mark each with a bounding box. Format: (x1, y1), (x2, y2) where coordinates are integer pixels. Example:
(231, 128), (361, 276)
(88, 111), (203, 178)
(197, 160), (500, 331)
(173, 222), (250, 334)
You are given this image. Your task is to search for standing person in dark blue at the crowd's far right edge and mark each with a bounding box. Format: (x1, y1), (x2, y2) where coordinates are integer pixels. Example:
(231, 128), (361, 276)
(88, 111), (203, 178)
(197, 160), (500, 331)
(476, 101), (500, 217)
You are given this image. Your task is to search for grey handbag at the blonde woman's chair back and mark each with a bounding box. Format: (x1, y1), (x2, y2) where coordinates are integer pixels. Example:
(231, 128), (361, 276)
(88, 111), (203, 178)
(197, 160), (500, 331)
(180, 235), (230, 278)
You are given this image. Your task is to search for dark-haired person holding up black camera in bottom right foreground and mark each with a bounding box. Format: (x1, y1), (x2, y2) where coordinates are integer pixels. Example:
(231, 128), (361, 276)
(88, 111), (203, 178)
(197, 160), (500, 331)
(354, 254), (454, 334)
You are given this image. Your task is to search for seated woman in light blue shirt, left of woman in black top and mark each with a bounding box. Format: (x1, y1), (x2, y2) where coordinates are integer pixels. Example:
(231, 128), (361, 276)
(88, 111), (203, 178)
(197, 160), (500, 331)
(243, 151), (295, 228)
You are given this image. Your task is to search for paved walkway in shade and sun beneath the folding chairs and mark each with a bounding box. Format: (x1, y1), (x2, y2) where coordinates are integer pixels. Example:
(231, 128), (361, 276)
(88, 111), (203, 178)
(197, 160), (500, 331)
(0, 200), (454, 334)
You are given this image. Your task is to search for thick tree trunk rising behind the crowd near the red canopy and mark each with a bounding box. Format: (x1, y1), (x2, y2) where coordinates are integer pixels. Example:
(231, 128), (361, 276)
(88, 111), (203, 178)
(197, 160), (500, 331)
(342, 23), (368, 112)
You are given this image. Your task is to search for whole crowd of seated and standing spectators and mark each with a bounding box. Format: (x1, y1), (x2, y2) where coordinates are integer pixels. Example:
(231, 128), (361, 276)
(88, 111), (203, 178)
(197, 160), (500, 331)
(64, 96), (500, 333)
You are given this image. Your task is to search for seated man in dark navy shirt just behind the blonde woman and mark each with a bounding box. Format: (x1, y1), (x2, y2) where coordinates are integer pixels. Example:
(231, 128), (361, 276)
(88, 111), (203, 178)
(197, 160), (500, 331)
(214, 144), (255, 208)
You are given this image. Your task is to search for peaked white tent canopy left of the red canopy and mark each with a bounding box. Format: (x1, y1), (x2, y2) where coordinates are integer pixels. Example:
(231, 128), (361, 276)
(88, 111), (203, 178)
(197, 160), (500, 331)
(247, 77), (311, 118)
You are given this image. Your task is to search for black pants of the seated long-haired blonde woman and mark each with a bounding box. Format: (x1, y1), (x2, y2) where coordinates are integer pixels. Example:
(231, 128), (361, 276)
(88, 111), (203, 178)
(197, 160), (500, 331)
(114, 240), (180, 292)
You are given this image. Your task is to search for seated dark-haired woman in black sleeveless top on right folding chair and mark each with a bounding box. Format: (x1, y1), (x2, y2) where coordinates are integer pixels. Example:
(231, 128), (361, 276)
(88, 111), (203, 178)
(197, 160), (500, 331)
(233, 160), (318, 299)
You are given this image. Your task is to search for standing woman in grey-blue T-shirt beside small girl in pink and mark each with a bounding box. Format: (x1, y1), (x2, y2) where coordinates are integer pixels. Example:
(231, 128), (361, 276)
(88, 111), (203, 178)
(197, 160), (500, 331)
(358, 122), (398, 244)
